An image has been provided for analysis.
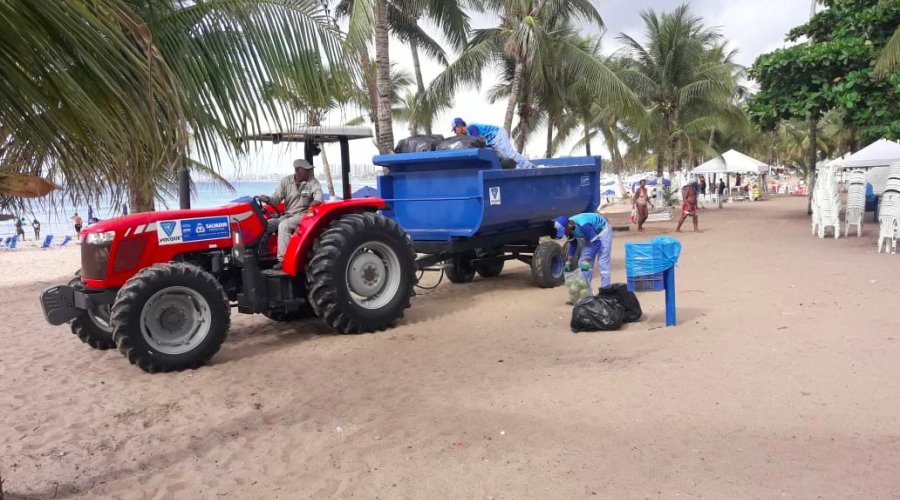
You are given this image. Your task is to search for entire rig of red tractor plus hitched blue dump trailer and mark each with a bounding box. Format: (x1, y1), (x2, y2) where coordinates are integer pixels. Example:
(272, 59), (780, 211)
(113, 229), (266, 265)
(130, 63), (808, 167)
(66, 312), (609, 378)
(41, 127), (600, 373)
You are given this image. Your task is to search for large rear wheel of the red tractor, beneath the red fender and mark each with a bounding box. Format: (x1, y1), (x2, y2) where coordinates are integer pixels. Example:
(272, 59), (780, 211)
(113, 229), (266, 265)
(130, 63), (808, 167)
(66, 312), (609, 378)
(306, 212), (416, 333)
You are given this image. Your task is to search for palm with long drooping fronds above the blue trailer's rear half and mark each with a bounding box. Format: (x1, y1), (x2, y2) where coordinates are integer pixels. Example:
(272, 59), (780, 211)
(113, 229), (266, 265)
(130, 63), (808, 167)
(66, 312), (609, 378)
(430, 0), (640, 133)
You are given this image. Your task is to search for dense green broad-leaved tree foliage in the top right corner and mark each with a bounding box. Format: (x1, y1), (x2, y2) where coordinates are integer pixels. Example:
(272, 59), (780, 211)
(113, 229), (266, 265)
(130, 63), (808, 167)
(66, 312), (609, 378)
(749, 0), (900, 142)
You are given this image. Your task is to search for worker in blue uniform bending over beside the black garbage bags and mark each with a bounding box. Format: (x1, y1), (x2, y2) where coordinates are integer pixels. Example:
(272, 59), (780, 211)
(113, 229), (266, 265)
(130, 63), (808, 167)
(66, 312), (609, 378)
(553, 212), (612, 286)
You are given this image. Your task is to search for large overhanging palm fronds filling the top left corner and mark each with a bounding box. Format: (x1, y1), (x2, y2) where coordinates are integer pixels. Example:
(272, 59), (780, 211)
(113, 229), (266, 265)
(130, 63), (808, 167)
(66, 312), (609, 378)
(0, 0), (343, 210)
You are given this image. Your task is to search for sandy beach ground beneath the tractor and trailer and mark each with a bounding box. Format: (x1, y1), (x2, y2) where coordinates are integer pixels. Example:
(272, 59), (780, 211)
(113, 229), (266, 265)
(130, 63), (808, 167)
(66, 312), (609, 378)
(0, 198), (900, 500)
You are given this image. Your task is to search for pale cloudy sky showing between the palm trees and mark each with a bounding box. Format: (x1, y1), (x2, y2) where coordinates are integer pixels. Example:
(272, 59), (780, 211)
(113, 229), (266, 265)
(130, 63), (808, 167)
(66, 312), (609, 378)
(222, 0), (821, 179)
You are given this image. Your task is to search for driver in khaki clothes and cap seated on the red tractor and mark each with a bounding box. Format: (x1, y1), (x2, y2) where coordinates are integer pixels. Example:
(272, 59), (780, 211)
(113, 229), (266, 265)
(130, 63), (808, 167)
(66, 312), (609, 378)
(259, 160), (323, 269)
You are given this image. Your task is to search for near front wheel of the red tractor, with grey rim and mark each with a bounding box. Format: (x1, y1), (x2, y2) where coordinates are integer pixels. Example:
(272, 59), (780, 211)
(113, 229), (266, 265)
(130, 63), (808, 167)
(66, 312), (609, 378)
(112, 262), (231, 373)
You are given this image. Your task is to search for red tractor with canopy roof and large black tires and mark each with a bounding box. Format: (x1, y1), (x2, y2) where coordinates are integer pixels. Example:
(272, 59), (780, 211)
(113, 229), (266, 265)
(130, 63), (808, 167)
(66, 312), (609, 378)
(41, 127), (416, 372)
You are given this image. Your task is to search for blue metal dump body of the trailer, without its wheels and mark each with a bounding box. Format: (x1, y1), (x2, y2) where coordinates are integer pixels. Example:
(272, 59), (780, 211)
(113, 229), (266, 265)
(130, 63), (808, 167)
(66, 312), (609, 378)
(373, 149), (600, 241)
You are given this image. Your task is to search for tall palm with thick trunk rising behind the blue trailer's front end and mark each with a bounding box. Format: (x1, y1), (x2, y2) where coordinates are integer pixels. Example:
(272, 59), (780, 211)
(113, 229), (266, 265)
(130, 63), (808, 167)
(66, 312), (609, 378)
(336, 0), (469, 153)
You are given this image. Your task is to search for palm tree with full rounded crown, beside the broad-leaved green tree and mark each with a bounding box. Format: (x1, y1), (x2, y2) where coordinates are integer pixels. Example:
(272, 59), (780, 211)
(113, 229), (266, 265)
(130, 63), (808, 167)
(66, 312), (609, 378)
(619, 5), (734, 177)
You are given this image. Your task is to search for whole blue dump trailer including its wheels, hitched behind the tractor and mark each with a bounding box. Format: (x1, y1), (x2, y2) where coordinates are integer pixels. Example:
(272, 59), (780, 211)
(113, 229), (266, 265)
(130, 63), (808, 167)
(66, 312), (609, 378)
(373, 149), (600, 288)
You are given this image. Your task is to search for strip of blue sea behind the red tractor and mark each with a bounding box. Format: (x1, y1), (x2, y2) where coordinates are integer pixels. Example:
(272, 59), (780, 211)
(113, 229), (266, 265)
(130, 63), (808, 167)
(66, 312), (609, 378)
(0, 177), (376, 241)
